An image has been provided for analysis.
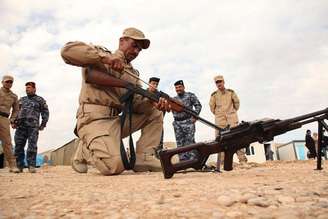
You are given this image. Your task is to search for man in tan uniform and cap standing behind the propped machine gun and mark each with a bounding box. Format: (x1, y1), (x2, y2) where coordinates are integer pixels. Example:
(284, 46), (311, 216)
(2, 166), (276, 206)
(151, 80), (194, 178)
(209, 75), (247, 169)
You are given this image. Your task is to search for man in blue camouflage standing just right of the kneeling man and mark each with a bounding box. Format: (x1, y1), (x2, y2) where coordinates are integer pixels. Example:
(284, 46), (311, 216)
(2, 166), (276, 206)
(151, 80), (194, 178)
(173, 80), (202, 161)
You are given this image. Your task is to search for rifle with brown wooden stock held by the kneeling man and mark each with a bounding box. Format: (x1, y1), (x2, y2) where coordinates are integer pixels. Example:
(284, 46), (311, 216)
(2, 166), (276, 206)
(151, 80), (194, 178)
(86, 68), (220, 130)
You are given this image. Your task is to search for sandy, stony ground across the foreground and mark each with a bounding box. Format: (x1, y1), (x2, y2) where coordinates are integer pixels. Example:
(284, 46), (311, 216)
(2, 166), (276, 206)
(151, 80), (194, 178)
(0, 161), (328, 219)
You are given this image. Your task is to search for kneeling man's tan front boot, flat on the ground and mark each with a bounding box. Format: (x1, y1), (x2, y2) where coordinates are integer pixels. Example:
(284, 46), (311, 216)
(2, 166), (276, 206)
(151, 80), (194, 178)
(133, 151), (162, 172)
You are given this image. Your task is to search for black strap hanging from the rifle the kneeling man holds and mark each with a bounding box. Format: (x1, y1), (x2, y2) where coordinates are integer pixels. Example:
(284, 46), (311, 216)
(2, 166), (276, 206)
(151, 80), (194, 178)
(120, 91), (136, 170)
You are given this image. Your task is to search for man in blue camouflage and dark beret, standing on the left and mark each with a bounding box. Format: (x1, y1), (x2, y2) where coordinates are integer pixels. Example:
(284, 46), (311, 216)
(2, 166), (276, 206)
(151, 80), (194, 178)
(15, 82), (49, 173)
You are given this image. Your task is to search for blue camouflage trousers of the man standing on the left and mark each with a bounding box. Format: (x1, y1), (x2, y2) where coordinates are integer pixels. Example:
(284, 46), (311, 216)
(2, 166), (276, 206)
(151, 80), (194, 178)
(14, 125), (39, 168)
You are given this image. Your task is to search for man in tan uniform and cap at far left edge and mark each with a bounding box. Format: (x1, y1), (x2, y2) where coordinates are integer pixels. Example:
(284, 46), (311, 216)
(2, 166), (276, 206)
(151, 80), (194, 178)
(0, 75), (19, 173)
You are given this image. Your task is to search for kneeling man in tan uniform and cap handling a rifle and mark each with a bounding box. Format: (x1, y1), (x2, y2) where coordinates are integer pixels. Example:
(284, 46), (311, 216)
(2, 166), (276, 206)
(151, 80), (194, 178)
(61, 28), (169, 175)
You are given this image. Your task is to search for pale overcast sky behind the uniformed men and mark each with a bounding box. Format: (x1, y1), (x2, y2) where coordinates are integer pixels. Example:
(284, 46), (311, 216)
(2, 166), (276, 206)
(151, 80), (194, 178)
(0, 0), (328, 152)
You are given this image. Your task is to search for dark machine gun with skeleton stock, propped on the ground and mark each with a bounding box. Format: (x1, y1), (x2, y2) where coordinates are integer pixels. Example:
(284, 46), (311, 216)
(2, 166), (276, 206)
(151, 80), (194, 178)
(159, 108), (328, 179)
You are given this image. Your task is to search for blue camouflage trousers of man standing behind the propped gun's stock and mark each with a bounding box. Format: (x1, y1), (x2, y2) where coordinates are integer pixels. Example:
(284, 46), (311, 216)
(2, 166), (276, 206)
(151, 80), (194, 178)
(173, 119), (197, 161)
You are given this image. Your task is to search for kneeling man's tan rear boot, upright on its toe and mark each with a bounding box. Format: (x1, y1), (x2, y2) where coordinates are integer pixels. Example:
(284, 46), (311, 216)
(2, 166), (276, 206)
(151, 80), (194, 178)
(72, 138), (88, 173)
